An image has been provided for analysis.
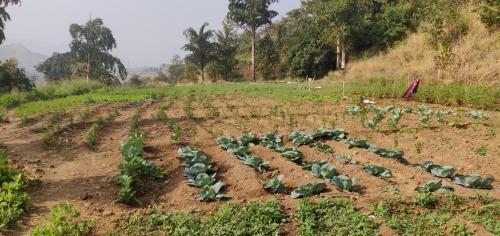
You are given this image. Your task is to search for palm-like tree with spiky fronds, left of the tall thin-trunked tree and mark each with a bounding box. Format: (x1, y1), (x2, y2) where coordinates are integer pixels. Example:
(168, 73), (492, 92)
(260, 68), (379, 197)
(183, 23), (214, 83)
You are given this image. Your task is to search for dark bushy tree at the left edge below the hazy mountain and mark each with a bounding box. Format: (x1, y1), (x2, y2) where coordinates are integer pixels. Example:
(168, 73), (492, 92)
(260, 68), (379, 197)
(0, 59), (35, 93)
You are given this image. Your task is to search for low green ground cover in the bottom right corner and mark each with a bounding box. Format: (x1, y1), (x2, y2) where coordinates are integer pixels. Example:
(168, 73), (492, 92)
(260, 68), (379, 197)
(370, 192), (500, 235)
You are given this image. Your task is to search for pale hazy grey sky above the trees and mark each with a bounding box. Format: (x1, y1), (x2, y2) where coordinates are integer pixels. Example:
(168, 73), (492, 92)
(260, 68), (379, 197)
(4, 0), (300, 68)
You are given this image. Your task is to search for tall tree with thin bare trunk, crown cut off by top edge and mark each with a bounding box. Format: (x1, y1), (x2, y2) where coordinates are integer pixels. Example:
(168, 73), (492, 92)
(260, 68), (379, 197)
(228, 0), (278, 80)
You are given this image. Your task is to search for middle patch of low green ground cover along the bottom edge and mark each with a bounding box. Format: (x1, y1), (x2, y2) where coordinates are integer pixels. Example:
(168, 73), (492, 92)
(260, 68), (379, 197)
(297, 198), (378, 236)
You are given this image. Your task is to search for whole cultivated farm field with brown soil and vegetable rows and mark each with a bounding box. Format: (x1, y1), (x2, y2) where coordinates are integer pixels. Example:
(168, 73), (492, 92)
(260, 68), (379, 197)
(0, 84), (500, 235)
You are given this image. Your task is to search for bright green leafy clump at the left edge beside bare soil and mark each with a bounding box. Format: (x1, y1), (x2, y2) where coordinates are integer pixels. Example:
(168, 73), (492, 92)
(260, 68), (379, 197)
(0, 148), (30, 229)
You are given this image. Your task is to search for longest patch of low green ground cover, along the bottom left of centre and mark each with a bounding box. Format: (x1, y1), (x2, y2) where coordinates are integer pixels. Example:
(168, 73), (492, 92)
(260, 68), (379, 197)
(116, 200), (285, 235)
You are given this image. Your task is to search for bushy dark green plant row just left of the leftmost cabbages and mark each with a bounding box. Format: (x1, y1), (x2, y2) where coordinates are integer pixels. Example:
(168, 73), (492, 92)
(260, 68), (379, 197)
(118, 132), (164, 204)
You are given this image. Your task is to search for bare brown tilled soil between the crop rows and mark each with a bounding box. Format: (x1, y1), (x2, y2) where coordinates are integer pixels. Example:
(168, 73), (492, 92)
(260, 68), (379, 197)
(0, 96), (500, 235)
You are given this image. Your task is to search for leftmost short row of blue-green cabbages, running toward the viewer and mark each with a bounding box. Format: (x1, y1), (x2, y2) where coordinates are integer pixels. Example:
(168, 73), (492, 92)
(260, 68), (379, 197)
(178, 147), (229, 202)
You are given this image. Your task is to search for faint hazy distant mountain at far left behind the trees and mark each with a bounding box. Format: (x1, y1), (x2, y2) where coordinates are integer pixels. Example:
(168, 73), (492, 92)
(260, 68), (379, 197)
(0, 44), (49, 79)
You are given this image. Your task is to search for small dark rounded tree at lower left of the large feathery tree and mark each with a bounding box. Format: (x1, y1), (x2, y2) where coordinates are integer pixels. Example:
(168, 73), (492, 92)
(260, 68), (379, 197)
(36, 52), (73, 81)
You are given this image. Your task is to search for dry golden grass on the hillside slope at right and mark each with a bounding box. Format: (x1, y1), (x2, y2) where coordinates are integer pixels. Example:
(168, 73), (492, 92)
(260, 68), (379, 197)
(329, 7), (500, 86)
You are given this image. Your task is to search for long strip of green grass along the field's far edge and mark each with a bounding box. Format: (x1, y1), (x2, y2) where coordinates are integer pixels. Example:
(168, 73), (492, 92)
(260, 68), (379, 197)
(11, 78), (500, 116)
